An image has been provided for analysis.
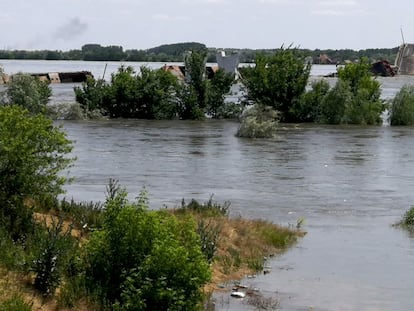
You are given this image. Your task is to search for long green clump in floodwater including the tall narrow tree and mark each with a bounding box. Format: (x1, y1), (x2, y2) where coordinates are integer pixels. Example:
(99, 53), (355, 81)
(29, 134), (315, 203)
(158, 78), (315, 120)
(75, 51), (234, 120)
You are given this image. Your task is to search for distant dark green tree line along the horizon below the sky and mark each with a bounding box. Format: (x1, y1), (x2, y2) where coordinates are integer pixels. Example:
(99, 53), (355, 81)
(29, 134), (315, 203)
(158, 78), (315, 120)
(0, 42), (398, 64)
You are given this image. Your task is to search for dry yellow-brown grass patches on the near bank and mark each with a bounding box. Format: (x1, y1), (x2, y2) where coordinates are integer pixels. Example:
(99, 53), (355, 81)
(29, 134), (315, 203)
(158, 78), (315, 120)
(0, 206), (304, 311)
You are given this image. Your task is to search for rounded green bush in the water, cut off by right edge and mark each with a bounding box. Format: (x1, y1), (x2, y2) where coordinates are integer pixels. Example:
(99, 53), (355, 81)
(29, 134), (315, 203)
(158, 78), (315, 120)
(389, 85), (414, 125)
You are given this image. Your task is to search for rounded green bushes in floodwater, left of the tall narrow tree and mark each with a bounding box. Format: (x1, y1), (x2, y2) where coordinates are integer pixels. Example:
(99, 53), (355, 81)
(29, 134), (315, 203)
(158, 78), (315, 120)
(75, 66), (178, 119)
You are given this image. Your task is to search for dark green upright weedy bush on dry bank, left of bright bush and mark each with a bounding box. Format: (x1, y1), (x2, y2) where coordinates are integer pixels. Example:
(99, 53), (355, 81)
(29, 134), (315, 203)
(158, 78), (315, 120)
(31, 219), (75, 296)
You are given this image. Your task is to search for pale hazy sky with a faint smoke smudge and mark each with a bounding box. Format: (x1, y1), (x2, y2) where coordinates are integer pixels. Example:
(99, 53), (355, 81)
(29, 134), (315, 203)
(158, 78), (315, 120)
(0, 0), (414, 51)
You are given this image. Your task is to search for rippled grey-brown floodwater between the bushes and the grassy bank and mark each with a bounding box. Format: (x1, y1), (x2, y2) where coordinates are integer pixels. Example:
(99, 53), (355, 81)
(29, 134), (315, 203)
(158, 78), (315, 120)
(0, 61), (414, 311)
